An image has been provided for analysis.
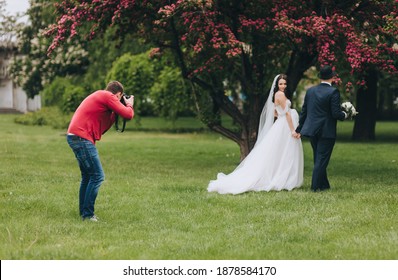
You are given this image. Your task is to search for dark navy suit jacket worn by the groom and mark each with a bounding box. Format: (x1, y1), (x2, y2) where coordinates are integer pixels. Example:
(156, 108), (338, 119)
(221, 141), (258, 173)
(296, 83), (345, 138)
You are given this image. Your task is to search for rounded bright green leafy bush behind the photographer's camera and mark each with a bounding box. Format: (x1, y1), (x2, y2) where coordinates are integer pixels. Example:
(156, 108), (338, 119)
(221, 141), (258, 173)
(106, 50), (196, 120)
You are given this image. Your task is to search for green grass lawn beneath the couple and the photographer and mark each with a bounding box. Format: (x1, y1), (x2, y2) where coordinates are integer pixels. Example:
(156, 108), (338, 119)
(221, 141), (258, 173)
(0, 115), (398, 260)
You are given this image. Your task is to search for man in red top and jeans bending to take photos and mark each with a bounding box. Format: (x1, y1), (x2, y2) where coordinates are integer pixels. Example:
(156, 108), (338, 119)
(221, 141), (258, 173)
(66, 81), (134, 222)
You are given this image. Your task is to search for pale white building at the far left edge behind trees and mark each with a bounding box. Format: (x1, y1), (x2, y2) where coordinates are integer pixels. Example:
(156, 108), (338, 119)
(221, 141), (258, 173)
(0, 46), (41, 113)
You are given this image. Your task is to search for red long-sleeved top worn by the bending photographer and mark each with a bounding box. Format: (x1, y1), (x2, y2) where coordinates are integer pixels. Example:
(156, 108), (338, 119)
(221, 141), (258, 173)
(68, 90), (134, 144)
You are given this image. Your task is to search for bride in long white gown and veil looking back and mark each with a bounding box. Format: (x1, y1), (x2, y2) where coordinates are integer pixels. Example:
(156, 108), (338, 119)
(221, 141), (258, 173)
(207, 74), (304, 194)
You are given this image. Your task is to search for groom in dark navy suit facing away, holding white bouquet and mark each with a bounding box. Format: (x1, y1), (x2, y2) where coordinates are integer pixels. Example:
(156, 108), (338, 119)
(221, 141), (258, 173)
(296, 65), (347, 192)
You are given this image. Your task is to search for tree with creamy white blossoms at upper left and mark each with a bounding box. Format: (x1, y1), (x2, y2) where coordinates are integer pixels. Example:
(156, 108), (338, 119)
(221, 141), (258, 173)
(10, 0), (88, 97)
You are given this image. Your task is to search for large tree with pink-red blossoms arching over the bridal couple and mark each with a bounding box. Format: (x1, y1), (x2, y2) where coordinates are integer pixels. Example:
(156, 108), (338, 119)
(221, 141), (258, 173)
(47, 0), (397, 158)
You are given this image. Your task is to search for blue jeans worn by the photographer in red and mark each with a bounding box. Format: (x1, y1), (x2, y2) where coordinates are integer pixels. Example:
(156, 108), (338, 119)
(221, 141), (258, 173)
(66, 135), (105, 219)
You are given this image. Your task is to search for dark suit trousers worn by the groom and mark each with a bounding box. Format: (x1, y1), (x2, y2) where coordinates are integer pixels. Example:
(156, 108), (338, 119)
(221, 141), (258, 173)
(310, 136), (336, 191)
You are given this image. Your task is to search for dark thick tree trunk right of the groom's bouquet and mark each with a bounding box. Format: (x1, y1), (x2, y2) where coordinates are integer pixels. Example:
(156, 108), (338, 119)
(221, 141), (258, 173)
(352, 69), (378, 140)
